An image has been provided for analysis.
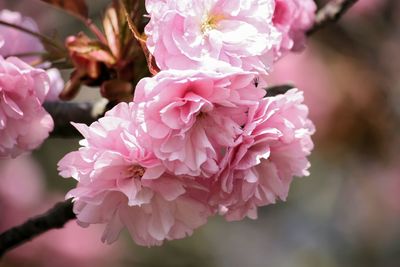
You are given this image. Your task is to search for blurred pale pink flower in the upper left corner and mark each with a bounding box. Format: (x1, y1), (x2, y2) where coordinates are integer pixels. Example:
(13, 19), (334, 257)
(0, 9), (44, 63)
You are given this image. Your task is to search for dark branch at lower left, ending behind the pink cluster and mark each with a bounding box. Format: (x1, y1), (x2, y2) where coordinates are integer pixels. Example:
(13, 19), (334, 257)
(0, 200), (75, 258)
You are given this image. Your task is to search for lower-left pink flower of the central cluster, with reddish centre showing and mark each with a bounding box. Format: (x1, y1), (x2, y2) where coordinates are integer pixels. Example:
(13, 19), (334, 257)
(59, 103), (209, 246)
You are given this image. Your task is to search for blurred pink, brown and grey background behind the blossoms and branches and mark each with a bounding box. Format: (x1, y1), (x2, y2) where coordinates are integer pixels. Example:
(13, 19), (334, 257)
(0, 0), (400, 267)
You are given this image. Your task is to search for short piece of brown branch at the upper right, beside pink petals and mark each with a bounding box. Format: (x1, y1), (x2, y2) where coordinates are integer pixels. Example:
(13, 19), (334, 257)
(307, 0), (358, 36)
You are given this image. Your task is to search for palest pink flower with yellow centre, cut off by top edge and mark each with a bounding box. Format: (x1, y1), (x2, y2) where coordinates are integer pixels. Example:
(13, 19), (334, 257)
(145, 0), (280, 74)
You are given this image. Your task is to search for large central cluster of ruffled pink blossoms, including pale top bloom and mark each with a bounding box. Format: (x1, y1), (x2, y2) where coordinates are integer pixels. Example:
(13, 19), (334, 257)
(59, 0), (315, 246)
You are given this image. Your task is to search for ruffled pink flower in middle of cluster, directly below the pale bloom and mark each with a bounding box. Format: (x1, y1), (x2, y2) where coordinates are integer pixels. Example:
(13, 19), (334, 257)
(134, 70), (265, 177)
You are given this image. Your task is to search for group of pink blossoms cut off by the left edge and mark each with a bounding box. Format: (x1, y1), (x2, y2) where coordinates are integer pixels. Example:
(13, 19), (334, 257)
(0, 9), (64, 158)
